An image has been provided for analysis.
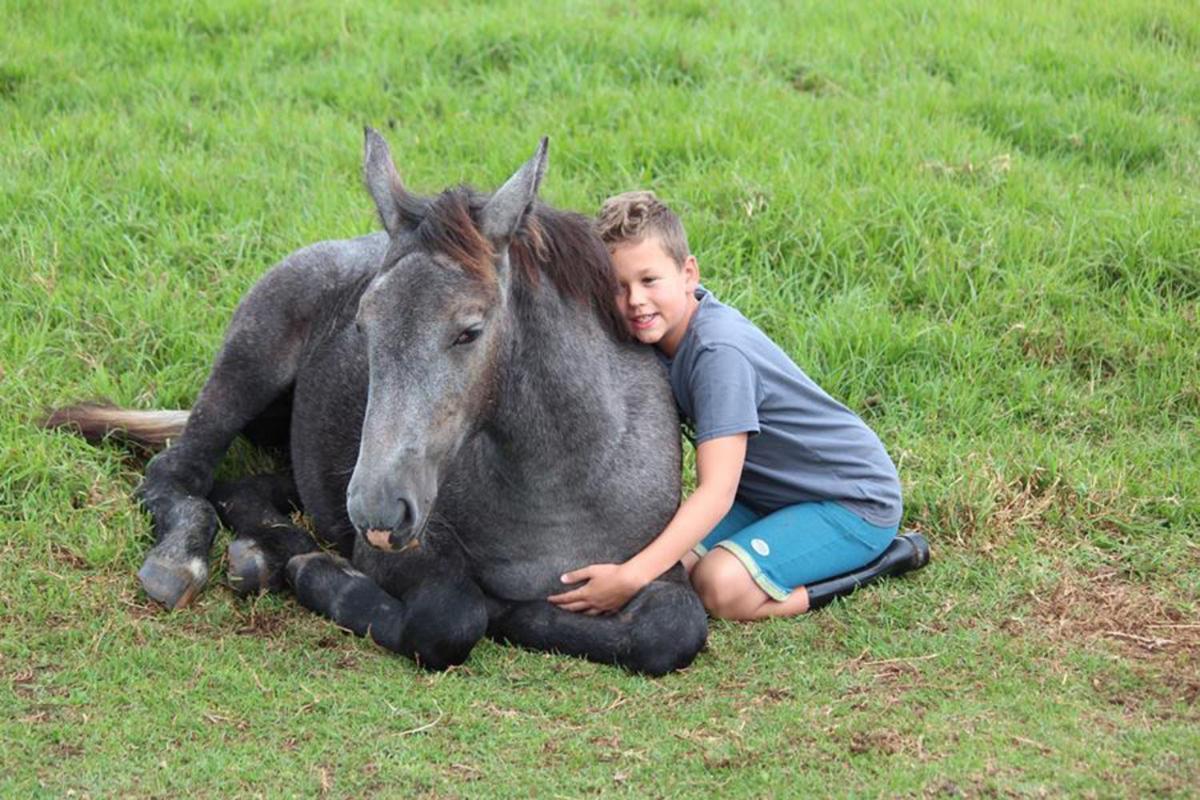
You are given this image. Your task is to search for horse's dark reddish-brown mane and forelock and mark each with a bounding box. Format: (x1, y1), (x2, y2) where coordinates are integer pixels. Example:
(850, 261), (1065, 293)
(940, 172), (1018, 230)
(401, 186), (630, 342)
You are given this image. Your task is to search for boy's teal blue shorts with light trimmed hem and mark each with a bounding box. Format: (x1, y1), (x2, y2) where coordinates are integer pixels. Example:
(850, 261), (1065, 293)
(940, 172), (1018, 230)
(694, 500), (899, 600)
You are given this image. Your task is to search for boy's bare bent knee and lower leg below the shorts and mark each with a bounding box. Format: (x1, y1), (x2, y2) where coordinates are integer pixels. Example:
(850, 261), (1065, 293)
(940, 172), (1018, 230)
(684, 548), (809, 621)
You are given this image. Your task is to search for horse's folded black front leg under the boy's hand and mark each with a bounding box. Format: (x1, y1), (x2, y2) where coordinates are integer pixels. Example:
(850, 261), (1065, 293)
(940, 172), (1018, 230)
(488, 581), (708, 675)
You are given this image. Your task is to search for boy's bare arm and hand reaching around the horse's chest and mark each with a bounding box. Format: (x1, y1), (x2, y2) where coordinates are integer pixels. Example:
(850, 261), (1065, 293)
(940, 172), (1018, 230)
(548, 433), (746, 614)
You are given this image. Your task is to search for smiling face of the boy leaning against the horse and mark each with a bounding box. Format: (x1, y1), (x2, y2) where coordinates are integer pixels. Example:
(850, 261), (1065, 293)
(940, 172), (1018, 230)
(612, 236), (700, 355)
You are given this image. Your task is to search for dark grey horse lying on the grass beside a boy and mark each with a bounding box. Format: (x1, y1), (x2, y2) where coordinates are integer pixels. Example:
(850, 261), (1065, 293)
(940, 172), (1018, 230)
(50, 130), (707, 675)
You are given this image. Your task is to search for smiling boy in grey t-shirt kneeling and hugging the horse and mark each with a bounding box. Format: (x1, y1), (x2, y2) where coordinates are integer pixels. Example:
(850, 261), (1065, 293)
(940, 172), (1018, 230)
(550, 192), (929, 620)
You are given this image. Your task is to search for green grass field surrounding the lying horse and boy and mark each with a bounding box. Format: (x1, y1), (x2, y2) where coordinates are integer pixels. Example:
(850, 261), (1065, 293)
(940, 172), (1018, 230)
(0, 0), (1200, 798)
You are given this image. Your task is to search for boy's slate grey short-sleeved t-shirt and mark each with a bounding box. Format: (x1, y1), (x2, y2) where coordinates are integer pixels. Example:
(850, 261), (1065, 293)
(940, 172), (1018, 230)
(659, 288), (902, 527)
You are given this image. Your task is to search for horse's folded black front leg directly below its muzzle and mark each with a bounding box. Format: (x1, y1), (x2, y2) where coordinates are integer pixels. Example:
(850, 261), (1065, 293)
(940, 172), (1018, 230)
(287, 553), (487, 669)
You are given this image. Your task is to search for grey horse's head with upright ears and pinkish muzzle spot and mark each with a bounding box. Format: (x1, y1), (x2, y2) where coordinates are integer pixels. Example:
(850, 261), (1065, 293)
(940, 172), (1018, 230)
(347, 130), (546, 549)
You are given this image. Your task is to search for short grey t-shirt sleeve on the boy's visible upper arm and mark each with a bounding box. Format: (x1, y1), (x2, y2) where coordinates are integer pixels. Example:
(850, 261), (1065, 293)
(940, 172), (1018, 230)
(689, 347), (758, 445)
